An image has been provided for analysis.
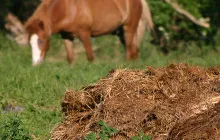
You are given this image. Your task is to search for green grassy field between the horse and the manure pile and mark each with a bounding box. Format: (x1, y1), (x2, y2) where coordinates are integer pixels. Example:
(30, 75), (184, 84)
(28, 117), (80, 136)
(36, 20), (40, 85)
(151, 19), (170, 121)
(0, 32), (220, 139)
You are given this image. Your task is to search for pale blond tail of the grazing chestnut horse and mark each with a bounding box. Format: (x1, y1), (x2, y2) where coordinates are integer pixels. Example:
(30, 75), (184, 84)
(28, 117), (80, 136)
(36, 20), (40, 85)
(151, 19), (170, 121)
(134, 0), (154, 46)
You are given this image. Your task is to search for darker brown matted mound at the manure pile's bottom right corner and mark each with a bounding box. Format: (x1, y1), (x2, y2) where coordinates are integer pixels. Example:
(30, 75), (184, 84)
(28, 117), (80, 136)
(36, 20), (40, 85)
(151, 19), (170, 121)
(168, 103), (220, 140)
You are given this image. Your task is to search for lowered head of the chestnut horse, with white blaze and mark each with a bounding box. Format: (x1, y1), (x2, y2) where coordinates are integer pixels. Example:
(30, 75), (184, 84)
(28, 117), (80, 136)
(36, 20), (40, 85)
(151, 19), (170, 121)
(26, 19), (49, 65)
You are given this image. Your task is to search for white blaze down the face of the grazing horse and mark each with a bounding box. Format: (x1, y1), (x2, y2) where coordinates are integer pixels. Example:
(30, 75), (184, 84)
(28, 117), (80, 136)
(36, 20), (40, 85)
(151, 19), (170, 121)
(30, 34), (42, 65)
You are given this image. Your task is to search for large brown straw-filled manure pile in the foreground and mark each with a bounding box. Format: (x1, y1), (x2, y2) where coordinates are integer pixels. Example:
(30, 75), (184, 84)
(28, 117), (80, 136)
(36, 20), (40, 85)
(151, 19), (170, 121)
(51, 64), (220, 140)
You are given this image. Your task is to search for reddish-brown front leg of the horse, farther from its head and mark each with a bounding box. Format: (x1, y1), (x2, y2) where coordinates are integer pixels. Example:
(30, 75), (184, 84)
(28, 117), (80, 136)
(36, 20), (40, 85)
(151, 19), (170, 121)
(79, 31), (94, 62)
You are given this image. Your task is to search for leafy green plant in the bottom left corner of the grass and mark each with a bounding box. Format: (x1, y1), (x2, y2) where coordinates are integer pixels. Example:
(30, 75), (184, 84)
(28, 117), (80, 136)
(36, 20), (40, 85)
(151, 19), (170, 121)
(0, 116), (32, 140)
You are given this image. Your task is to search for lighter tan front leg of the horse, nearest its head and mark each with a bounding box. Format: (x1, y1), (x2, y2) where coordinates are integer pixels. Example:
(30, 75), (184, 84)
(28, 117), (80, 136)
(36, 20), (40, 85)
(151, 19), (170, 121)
(64, 39), (74, 64)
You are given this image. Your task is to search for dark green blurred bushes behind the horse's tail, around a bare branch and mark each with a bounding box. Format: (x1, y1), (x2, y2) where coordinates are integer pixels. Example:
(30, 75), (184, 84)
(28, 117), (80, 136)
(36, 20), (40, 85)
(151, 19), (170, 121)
(147, 0), (220, 51)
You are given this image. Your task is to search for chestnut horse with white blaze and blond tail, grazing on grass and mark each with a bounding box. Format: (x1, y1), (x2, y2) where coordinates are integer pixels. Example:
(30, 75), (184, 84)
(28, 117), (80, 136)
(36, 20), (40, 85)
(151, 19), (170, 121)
(26, 0), (153, 65)
